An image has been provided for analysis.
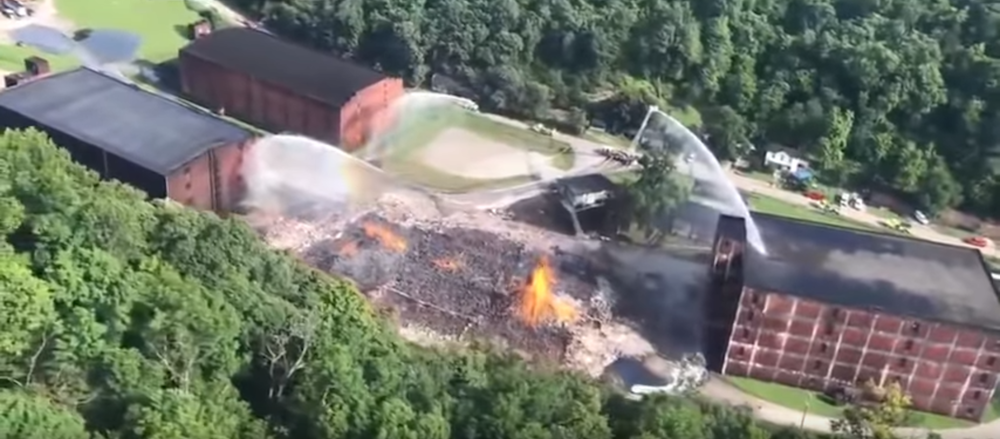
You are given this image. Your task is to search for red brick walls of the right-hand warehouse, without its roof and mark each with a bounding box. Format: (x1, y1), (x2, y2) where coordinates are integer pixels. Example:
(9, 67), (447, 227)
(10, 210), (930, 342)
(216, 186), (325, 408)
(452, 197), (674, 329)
(706, 217), (1000, 421)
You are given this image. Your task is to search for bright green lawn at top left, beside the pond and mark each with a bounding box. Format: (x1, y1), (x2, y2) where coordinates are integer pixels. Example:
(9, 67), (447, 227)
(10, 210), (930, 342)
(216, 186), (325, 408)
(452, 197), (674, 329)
(56, 0), (199, 63)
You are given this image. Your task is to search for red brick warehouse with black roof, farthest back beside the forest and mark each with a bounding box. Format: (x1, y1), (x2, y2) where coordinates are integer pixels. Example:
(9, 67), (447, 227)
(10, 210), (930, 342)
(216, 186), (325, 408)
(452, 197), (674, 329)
(180, 27), (403, 151)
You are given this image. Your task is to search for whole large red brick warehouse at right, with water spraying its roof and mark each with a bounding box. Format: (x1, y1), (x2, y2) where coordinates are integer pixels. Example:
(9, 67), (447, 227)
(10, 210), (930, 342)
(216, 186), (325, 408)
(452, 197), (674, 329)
(705, 214), (1000, 421)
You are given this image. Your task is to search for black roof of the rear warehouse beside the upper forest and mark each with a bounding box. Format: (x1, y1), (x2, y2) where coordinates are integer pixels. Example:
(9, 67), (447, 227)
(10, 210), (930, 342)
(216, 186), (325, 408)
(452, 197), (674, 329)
(181, 27), (386, 107)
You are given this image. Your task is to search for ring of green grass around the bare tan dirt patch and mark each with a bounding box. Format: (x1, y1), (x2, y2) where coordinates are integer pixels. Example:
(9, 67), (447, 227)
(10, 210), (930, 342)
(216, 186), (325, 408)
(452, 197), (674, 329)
(382, 110), (575, 192)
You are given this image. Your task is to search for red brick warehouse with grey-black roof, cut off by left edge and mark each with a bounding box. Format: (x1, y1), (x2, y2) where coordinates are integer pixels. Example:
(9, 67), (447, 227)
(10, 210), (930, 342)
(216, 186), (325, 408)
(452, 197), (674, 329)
(0, 68), (254, 211)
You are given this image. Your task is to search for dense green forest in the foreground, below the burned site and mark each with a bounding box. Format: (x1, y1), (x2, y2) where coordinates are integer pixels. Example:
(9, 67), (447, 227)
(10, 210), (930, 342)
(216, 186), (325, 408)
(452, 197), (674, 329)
(0, 127), (856, 439)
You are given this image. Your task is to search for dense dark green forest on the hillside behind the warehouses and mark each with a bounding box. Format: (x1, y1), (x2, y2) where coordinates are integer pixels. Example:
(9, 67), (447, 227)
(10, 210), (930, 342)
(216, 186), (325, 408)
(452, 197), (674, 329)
(234, 0), (1000, 214)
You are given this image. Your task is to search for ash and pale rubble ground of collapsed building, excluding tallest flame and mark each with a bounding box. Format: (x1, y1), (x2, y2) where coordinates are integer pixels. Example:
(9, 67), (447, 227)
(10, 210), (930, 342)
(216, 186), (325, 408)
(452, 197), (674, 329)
(252, 192), (698, 376)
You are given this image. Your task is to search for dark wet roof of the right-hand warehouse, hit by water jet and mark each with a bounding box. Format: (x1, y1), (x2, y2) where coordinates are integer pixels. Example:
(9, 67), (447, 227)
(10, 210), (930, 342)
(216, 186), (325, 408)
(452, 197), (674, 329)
(729, 213), (1000, 329)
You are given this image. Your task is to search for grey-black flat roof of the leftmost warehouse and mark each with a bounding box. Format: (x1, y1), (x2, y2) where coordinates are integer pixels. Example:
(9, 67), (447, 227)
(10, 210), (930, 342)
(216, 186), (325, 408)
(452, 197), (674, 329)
(0, 68), (252, 175)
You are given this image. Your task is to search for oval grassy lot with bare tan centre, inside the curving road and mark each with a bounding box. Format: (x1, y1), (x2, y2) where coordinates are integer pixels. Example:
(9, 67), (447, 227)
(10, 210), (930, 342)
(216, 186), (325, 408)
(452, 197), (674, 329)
(382, 110), (574, 192)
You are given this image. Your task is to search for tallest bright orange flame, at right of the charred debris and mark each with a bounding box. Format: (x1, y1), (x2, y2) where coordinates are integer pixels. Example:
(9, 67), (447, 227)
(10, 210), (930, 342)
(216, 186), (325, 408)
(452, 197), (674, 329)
(518, 256), (577, 326)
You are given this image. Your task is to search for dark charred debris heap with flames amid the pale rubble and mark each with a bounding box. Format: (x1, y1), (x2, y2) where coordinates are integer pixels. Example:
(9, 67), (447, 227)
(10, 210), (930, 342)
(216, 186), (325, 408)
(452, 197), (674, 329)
(303, 214), (599, 360)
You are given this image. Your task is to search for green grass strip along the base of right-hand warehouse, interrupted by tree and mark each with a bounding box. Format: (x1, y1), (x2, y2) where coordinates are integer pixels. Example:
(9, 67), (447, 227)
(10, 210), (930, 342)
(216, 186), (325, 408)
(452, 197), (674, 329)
(726, 377), (976, 430)
